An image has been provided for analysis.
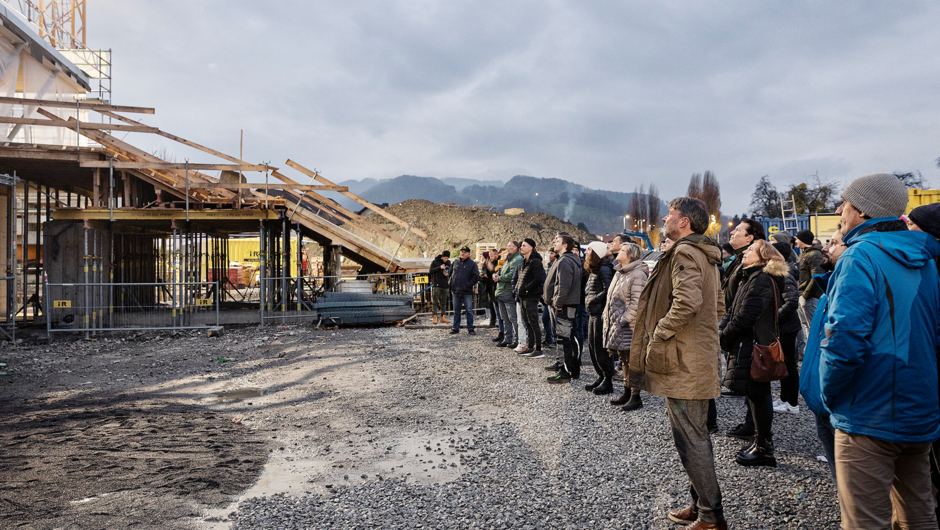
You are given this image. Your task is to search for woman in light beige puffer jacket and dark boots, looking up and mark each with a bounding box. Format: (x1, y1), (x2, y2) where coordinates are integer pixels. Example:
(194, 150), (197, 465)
(604, 243), (650, 412)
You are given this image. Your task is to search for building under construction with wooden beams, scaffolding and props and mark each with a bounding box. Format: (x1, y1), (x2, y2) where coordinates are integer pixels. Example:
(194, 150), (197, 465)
(0, 0), (427, 338)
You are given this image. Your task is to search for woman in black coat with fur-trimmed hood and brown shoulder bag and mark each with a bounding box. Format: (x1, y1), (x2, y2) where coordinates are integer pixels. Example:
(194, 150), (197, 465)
(719, 240), (790, 467)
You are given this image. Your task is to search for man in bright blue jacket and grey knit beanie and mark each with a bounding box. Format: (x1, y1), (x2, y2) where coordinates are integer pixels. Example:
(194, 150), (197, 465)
(819, 173), (940, 529)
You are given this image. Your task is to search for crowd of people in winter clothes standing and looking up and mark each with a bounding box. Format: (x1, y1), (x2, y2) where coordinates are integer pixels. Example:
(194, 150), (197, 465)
(430, 174), (940, 530)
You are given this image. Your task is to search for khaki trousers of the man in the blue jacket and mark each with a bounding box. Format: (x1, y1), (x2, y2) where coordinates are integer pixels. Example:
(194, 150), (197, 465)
(835, 429), (937, 530)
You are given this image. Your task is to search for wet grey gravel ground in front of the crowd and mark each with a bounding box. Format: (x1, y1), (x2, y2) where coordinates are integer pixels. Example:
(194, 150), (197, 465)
(0, 326), (839, 530)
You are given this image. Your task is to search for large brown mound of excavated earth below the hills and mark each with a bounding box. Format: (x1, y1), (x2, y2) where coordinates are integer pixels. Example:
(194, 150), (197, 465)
(350, 199), (597, 258)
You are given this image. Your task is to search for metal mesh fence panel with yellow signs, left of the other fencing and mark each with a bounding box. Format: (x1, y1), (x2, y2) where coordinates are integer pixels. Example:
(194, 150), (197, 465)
(45, 282), (219, 336)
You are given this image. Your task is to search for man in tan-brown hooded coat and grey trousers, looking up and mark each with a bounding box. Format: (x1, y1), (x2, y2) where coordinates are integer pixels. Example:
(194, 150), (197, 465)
(630, 197), (727, 530)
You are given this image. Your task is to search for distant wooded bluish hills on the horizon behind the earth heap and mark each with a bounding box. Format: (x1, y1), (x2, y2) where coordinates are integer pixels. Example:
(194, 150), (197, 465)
(339, 175), (666, 234)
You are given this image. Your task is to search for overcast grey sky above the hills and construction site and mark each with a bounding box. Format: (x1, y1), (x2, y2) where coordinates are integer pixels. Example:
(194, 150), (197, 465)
(88, 0), (940, 214)
